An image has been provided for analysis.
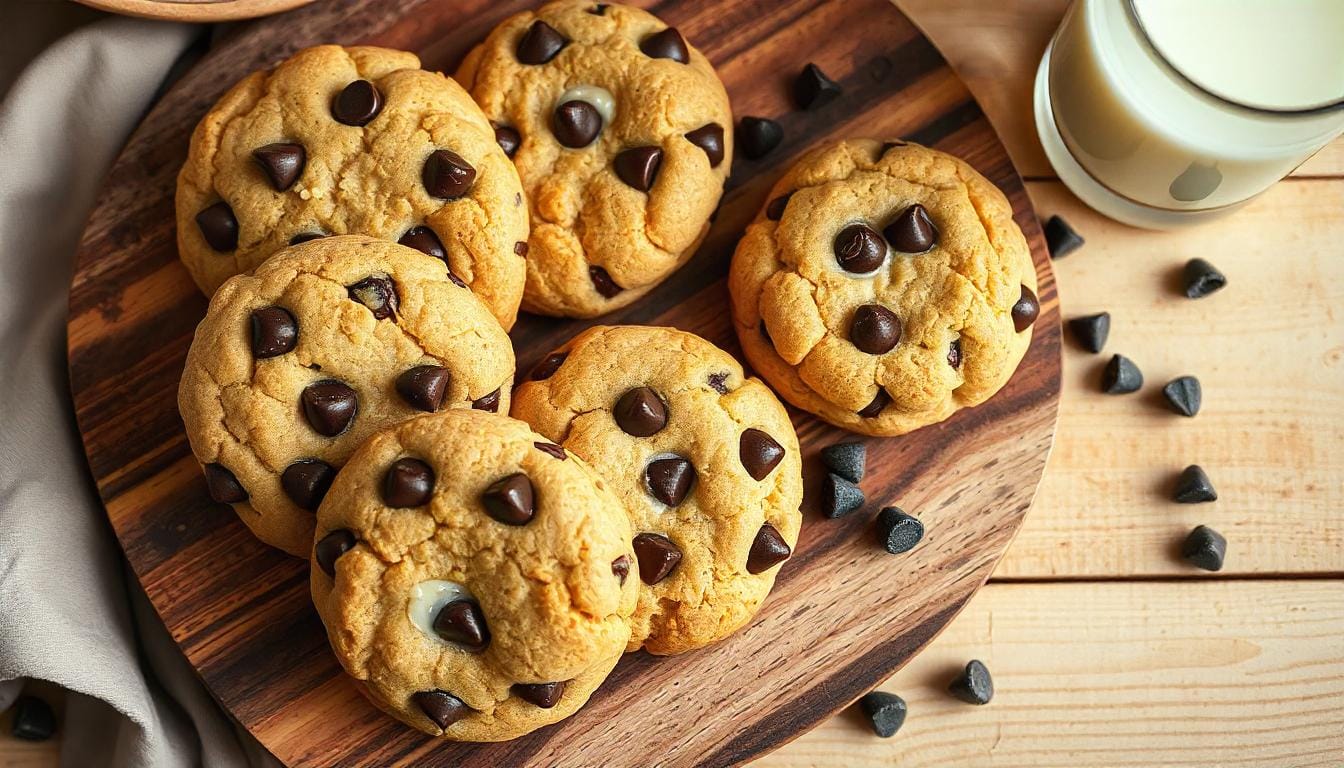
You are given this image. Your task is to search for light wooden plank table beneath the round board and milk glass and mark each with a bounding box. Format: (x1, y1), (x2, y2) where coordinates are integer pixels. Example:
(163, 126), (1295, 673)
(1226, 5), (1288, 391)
(0, 0), (1344, 768)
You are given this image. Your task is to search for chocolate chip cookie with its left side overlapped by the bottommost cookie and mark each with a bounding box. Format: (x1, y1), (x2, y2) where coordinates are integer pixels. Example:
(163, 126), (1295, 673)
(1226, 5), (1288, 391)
(513, 325), (802, 654)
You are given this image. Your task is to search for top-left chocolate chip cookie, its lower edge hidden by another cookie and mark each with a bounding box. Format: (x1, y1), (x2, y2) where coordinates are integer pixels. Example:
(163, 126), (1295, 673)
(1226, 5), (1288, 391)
(177, 46), (527, 330)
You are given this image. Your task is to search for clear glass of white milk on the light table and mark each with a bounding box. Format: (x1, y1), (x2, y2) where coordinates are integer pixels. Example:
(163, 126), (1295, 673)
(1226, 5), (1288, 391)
(1035, 0), (1344, 229)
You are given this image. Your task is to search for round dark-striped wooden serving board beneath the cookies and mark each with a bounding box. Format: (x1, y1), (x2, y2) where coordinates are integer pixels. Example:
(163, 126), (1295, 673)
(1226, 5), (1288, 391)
(69, 0), (1060, 765)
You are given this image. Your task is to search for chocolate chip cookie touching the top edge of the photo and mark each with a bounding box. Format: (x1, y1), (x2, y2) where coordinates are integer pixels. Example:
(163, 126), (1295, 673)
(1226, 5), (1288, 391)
(457, 1), (732, 317)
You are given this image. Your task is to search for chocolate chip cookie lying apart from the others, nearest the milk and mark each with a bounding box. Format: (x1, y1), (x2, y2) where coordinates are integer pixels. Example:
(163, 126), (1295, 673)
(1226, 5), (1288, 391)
(728, 140), (1040, 434)
